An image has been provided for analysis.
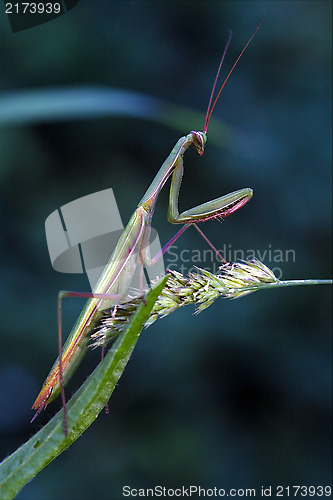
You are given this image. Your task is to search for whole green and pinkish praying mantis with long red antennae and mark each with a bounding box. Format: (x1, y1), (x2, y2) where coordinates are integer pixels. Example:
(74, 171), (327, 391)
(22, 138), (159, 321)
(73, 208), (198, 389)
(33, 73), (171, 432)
(32, 21), (263, 436)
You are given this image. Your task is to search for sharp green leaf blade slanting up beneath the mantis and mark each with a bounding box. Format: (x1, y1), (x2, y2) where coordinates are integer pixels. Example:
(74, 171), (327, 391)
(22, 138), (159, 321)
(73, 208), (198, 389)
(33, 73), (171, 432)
(0, 276), (168, 499)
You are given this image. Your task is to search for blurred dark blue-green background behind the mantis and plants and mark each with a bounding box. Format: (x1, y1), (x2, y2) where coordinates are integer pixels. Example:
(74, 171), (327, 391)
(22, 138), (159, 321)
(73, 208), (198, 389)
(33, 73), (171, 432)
(0, 0), (332, 499)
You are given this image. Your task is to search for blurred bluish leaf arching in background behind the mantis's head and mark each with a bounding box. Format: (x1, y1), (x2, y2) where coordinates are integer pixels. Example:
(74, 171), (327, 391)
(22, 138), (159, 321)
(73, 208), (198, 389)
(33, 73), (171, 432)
(0, 86), (233, 149)
